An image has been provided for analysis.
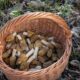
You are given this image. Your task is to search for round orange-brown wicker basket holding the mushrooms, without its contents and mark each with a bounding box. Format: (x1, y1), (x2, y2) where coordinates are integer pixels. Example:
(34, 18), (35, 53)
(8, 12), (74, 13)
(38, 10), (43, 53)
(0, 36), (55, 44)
(0, 12), (72, 80)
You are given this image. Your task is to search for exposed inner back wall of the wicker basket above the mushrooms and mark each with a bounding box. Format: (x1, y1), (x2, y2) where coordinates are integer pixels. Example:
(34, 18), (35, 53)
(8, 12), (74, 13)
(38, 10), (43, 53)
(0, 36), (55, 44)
(1, 18), (66, 70)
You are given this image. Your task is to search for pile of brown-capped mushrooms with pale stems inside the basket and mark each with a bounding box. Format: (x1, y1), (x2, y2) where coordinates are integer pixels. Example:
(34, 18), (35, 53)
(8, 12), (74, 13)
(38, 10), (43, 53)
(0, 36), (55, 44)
(3, 31), (61, 71)
